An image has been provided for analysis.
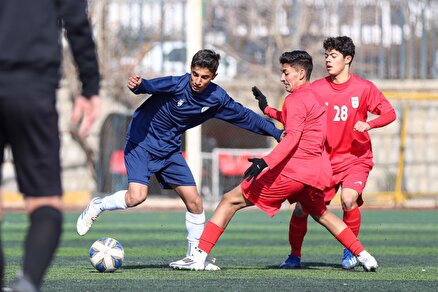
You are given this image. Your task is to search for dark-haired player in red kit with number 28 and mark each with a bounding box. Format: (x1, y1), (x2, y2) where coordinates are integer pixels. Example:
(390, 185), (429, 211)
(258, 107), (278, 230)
(280, 36), (396, 269)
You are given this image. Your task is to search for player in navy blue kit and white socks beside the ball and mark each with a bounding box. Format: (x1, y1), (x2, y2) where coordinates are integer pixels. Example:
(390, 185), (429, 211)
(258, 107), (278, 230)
(77, 50), (282, 270)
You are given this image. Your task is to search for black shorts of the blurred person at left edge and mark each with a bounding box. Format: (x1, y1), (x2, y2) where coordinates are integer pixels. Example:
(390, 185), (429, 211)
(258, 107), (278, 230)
(0, 90), (62, 197)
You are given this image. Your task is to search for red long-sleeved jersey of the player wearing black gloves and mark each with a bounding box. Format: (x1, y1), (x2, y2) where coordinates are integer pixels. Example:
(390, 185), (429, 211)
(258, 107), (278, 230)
(263, 83), (332, 190)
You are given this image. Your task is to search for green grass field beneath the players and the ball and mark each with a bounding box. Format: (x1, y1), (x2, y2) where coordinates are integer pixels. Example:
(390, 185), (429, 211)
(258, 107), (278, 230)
(2, 209), (438, 291)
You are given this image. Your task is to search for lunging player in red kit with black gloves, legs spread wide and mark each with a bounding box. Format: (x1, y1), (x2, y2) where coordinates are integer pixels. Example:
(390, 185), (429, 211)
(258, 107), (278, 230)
(173, 51), (378, 271)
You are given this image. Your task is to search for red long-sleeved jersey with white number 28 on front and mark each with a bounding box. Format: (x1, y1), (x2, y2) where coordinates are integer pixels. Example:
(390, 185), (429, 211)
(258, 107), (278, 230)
(312, 74), (395, 173)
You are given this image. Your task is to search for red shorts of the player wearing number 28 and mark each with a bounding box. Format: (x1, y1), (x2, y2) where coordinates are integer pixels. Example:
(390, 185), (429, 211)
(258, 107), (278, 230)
(324, 164), (372, 206)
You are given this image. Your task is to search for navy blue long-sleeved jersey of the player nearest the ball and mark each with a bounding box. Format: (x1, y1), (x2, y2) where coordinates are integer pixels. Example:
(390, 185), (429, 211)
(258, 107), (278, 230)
(127, 73), (282, 157)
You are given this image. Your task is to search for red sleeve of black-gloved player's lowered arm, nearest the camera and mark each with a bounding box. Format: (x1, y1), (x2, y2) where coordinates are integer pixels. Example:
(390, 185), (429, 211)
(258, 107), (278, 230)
(263, 98), (307, 169)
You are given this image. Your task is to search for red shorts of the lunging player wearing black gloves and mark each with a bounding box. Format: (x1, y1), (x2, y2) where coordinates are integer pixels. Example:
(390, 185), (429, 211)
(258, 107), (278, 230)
(241, 170), (327, 217)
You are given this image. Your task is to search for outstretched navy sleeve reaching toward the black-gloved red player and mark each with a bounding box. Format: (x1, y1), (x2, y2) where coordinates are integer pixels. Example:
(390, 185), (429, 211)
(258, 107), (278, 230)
(214, 94), (283, 141)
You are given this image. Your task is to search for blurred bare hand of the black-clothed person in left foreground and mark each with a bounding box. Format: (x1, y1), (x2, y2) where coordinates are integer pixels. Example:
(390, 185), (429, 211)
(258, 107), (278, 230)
(71, 95), (102, 138)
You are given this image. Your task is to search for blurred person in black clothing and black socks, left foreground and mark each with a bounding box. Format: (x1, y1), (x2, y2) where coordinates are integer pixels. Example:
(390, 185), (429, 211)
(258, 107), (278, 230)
(0, 0), (101, 291)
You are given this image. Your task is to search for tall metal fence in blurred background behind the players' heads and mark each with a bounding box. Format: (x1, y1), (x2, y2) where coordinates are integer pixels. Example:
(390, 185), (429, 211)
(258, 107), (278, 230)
(97, 0), (438, 79)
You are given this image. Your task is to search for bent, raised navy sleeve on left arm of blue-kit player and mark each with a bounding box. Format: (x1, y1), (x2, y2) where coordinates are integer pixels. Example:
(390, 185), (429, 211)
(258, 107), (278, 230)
(132, 74), (190, 94)
